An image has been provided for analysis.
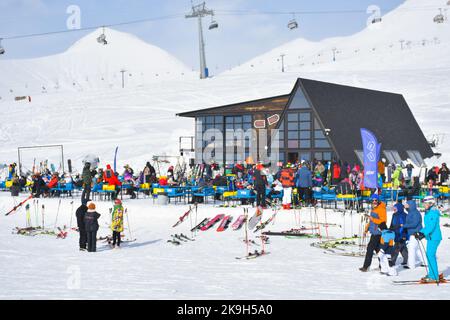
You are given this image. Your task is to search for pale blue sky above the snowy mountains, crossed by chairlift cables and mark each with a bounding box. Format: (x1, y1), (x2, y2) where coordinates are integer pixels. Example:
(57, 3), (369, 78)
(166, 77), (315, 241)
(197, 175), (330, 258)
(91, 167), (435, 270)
(0, 0), (403, 73)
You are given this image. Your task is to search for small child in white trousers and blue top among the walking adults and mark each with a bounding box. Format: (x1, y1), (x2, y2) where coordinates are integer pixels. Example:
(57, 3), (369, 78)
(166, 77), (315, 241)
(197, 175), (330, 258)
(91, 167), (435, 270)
(378, 222), (398, 276)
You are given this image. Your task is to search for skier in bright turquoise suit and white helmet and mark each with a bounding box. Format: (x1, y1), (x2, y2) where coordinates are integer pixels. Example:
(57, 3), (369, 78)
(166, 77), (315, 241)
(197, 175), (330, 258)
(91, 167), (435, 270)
(415, 196), (442, 282)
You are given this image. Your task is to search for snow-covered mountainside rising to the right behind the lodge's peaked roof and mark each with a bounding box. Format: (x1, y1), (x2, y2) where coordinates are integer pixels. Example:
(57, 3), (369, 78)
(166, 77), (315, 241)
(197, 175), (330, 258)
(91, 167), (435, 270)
(228, 0), (450, 74)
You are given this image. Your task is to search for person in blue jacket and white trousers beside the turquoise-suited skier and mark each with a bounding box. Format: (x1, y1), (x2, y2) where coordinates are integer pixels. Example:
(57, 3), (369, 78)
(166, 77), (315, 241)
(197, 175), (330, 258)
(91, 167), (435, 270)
(403, 200), (425, 269)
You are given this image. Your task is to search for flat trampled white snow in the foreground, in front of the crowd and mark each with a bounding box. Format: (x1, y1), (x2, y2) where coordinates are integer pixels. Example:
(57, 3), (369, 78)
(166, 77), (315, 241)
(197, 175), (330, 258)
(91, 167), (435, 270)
(0, 193), (450, 300)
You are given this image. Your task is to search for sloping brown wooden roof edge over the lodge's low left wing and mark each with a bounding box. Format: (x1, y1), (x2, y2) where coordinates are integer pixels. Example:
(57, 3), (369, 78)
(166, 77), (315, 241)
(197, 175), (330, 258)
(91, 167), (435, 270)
(177, 94), (290, 118)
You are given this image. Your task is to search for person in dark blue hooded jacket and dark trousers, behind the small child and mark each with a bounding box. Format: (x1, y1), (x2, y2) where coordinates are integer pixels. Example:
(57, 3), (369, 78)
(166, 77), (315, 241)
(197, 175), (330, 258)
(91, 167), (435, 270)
(389, 202), (408, 266)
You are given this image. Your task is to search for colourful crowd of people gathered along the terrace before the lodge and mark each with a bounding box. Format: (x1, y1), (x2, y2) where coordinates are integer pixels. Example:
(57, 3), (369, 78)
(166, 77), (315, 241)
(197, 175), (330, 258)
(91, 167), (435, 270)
(1, 159), (449, 209)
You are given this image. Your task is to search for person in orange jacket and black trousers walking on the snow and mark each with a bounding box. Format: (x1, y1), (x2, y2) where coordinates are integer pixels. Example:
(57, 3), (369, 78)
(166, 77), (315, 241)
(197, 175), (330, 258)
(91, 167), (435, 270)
(359, 194), (387, 272)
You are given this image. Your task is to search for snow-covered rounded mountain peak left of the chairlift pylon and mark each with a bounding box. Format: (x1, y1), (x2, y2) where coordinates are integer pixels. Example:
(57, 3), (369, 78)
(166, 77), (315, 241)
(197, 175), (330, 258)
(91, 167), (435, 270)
(0, 28), (194, 100)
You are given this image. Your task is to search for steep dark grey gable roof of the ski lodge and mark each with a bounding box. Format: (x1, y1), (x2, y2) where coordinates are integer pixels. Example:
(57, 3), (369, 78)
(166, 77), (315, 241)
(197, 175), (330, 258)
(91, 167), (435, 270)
(298, 79), (433, 163)
